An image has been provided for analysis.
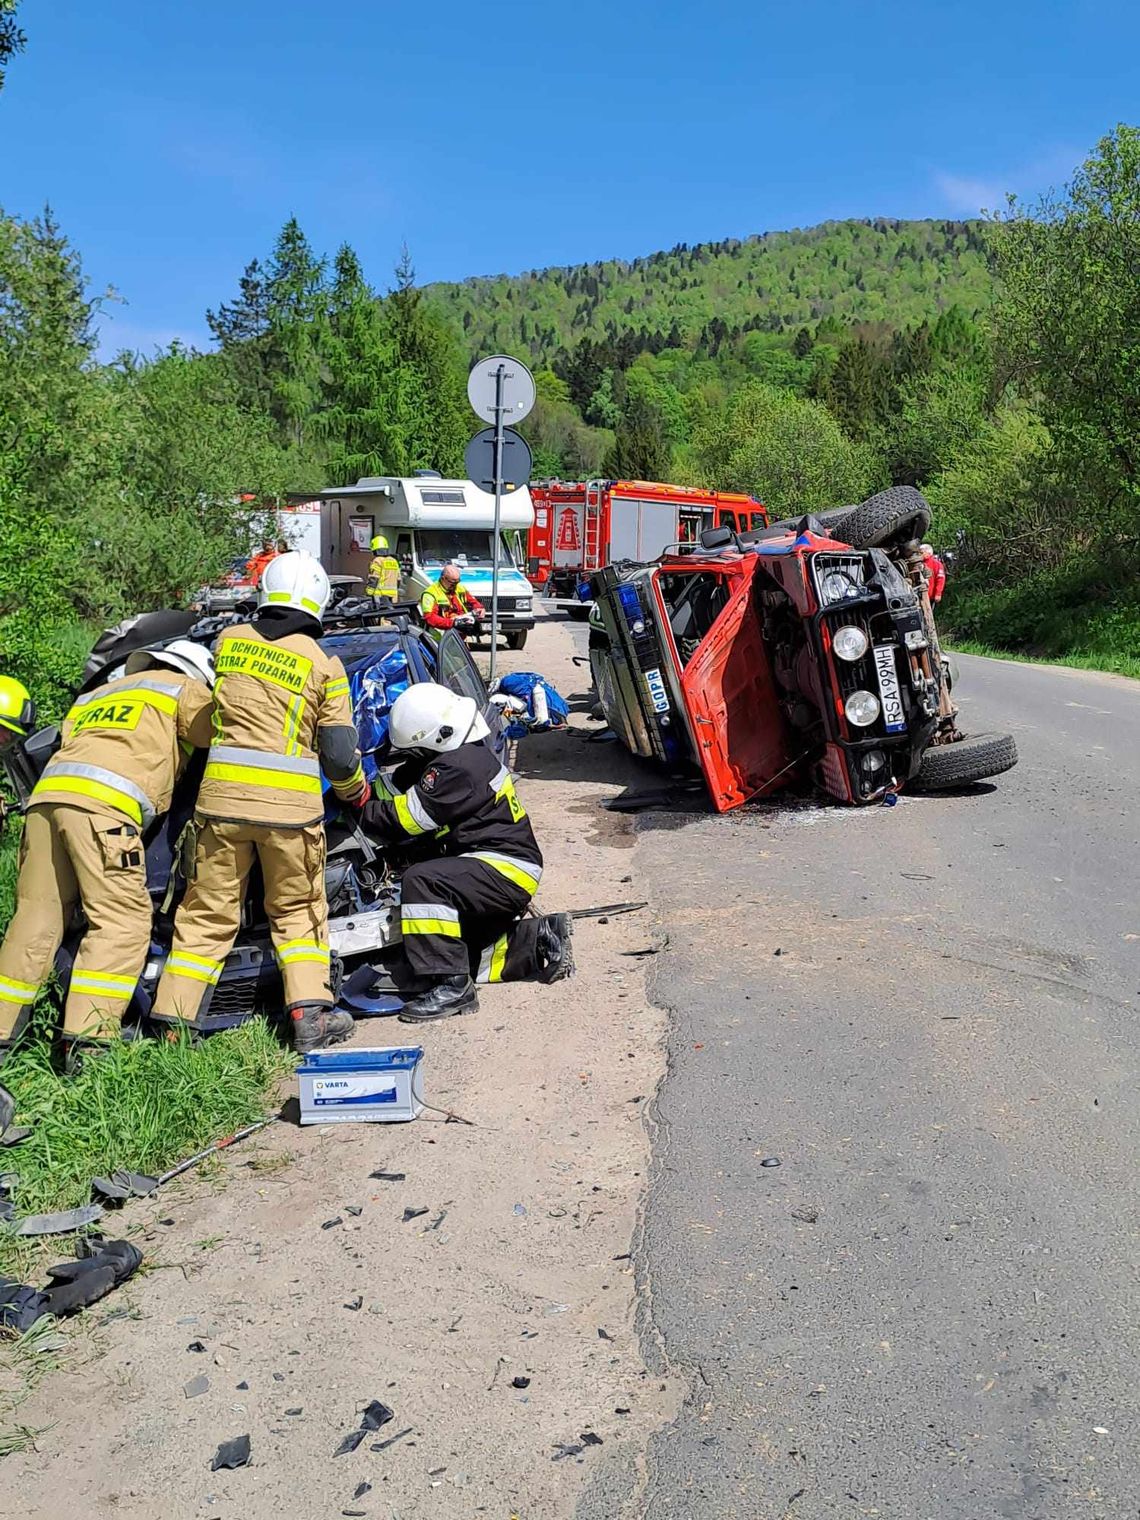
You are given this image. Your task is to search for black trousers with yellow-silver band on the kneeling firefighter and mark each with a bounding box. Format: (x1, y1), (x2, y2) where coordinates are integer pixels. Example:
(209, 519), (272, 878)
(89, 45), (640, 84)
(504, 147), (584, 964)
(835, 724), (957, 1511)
(400, 856), (534, 980)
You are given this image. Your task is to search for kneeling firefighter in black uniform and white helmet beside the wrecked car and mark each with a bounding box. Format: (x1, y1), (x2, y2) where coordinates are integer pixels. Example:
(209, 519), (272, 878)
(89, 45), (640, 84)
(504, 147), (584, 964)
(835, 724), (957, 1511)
(362, 681), (543, 1023)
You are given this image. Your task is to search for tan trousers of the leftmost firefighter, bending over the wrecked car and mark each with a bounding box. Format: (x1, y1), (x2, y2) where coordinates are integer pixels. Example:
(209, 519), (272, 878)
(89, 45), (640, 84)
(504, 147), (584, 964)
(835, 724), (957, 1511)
(0, 803), (152, 1040)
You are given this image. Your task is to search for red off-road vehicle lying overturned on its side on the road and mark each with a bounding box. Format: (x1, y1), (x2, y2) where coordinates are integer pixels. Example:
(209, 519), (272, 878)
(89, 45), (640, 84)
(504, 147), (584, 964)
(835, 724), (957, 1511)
(590, 486), (1017, 812)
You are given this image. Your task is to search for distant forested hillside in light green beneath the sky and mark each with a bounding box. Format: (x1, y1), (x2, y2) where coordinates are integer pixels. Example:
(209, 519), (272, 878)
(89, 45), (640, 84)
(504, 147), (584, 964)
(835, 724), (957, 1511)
(427, 219), (993, 366)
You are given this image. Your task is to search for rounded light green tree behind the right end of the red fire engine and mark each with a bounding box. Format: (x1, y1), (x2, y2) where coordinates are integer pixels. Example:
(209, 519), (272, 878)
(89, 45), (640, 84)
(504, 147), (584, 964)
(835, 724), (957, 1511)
(693, 383), (882, 517)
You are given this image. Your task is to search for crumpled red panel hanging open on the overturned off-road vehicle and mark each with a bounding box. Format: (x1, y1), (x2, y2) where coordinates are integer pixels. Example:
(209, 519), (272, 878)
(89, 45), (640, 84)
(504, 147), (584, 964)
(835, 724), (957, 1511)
(681, 575), (790, 813)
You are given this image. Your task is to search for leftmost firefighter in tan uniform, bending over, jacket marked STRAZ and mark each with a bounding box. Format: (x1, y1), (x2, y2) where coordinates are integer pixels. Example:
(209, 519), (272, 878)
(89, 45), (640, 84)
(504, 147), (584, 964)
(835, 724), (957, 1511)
(0, 638), (214, 1053)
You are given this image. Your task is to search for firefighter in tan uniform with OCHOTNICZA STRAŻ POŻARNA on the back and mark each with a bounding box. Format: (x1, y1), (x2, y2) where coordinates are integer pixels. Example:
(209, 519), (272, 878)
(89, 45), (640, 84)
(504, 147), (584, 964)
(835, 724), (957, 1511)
(152, 553), (369, 1050)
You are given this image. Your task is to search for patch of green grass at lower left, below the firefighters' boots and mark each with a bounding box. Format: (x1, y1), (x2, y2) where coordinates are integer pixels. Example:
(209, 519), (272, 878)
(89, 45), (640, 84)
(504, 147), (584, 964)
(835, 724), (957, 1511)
(0, 1014), (295, 1281)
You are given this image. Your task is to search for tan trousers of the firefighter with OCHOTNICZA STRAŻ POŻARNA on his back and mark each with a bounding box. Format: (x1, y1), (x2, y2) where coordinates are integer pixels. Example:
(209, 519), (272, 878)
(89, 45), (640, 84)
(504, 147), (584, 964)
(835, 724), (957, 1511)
(152, 818), (333, 1023)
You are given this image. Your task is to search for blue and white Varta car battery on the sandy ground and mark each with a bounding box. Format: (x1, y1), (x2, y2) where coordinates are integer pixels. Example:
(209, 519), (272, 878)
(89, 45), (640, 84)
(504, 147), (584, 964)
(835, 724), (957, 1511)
(296, 1046), (424, 1125)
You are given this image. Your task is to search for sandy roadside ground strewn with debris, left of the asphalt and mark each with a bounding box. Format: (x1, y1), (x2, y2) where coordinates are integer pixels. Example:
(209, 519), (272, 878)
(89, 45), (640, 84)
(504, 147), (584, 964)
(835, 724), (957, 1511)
(0, 620), (678, 1520)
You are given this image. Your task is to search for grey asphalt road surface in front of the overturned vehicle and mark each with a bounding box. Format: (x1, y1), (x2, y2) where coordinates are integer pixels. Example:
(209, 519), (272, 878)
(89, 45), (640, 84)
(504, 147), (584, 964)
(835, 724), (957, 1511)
(574, 644), (1140, 1520)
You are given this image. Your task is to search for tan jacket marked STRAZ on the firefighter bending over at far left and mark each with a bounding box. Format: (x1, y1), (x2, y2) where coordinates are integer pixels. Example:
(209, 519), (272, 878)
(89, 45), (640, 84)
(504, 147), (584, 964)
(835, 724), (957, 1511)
(30, 670), (213, 828)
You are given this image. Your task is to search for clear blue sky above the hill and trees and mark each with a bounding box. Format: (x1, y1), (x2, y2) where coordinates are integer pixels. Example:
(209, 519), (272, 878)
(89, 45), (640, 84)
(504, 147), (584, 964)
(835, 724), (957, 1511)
(0, 0), (1140, 351)
